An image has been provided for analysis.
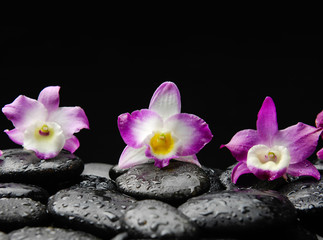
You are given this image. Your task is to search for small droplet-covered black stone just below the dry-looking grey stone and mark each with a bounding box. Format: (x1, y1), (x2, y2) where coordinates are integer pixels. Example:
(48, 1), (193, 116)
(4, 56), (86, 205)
(72, 175), (116, 190)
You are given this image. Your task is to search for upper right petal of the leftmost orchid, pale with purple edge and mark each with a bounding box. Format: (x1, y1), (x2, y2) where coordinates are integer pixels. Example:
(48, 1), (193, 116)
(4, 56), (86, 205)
(48, 107), (89, 139)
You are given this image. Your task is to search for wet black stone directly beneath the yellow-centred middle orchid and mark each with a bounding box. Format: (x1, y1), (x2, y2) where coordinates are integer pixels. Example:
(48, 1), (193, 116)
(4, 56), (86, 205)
(116, 161), (210, 205)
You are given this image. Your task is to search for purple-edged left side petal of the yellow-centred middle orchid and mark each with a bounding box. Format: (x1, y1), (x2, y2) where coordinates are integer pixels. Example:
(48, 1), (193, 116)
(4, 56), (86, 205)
(118, 109), (163, 148)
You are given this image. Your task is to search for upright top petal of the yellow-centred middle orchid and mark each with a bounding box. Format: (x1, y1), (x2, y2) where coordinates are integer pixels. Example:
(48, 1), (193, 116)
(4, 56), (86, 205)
(149, 82), (181, 119)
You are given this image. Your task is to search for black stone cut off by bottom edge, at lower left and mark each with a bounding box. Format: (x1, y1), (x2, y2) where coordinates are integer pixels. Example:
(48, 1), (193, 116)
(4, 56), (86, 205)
(7, 227), (99, 240)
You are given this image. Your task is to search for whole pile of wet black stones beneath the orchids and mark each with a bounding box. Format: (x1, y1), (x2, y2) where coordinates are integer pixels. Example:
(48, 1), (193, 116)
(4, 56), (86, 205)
(0, 149), (323, 240)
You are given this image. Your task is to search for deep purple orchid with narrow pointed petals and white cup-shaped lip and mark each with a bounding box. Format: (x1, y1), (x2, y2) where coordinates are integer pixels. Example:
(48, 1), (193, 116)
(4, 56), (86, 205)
(221, 97), (322, 183)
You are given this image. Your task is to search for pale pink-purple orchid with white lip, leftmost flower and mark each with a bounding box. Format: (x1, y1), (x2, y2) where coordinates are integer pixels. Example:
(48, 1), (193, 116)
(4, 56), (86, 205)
(2, 86), (89, 159)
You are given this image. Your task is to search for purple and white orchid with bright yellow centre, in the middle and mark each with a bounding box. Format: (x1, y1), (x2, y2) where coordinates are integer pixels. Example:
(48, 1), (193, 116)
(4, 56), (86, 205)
(118, 82), (213, 168)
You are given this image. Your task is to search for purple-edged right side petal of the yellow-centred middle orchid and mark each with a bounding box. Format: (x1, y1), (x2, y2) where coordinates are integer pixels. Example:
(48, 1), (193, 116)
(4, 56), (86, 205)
(165, 113), (213, 156)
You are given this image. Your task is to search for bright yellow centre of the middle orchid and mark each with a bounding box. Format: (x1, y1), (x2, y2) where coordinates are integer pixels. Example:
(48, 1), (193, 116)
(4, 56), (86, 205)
(150, 132), (174, 155)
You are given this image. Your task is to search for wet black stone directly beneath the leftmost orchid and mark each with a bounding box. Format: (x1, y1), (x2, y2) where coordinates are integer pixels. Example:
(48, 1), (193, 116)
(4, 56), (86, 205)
(0, 149), (84, 186)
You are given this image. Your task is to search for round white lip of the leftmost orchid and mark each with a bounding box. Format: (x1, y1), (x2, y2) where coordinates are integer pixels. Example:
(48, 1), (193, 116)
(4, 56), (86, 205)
(23, 122), (65, 159)
